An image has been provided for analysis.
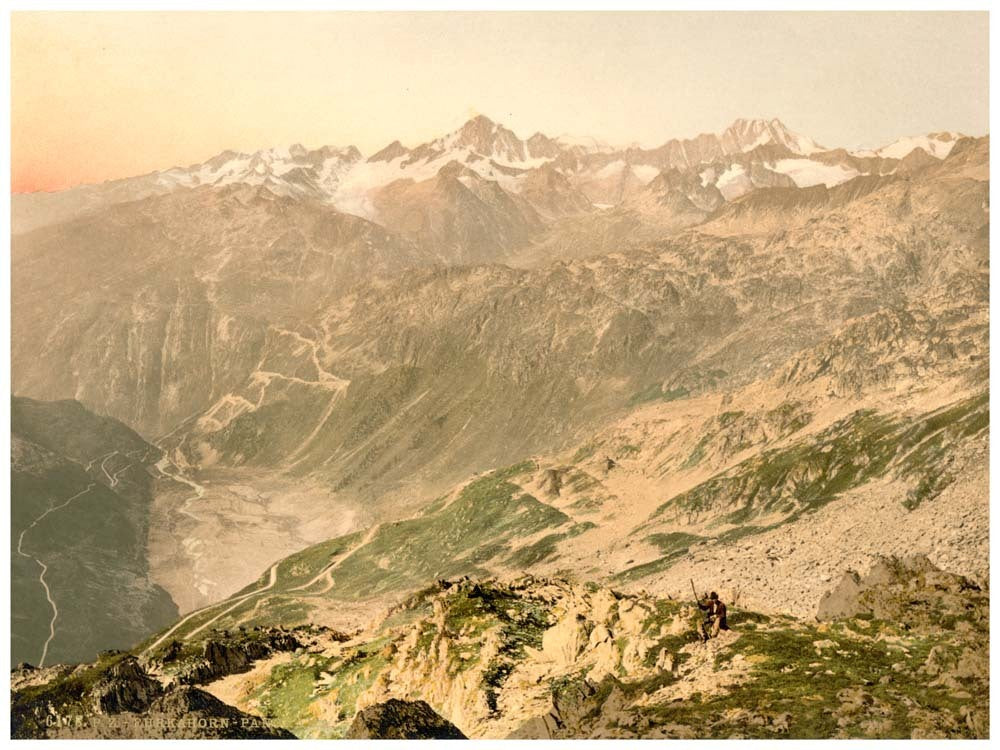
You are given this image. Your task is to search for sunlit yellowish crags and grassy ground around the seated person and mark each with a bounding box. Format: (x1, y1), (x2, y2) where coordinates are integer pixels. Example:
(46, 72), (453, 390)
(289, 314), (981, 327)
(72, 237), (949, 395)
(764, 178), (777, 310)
(195, 571), (988, 739)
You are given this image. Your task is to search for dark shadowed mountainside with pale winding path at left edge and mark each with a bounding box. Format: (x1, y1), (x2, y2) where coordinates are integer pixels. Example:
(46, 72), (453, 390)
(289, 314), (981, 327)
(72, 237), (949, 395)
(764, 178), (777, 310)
(10, 398), (177, 665)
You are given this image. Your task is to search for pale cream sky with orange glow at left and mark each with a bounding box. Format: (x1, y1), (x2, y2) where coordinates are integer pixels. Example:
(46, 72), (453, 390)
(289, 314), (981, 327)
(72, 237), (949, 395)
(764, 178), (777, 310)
(11, 12), (989, 191)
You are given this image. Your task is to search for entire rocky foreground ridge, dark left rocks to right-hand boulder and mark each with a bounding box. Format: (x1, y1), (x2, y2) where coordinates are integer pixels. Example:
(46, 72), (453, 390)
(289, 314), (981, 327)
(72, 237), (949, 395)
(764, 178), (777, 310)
(12, 558), (989, 738)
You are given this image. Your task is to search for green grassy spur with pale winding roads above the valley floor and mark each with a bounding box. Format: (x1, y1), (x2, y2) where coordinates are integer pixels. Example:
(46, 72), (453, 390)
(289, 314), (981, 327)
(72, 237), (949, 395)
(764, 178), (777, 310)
(147, 462), (586, 643)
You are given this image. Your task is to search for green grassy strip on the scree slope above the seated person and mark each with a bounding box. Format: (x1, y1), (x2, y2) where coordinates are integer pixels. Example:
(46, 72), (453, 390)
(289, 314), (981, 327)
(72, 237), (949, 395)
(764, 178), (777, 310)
(617, 393), (989, 580)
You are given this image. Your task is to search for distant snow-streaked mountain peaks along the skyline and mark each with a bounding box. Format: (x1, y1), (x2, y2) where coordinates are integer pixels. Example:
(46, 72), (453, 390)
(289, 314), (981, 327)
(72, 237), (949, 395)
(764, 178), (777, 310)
(12, 115), (962, 232)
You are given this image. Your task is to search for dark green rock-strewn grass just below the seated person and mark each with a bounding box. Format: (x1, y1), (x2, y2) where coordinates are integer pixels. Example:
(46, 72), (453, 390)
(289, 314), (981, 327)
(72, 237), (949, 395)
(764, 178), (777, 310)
(646, 618), (984, 739)
